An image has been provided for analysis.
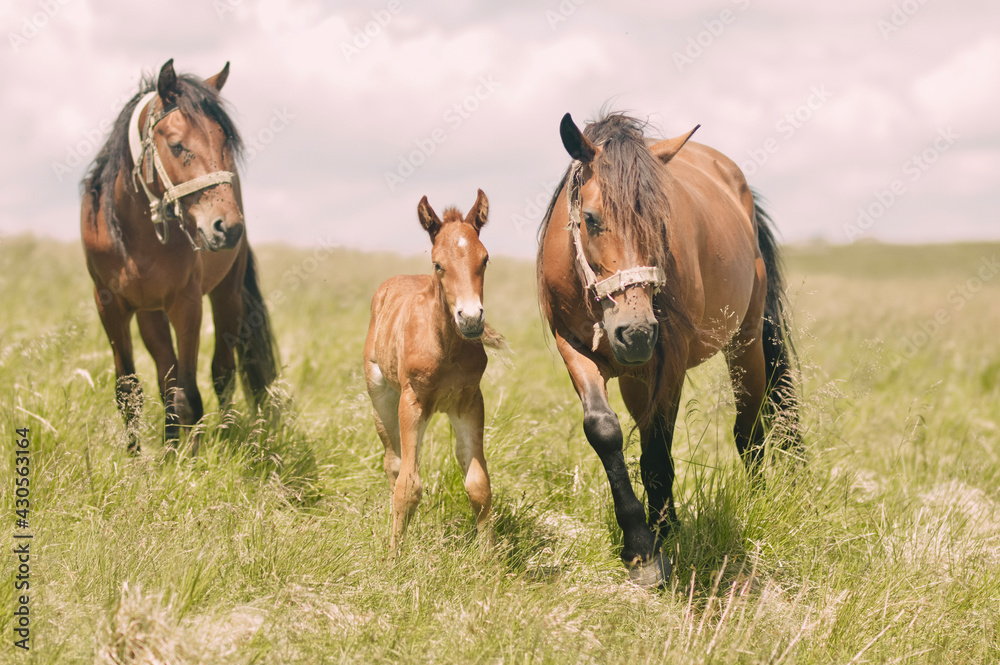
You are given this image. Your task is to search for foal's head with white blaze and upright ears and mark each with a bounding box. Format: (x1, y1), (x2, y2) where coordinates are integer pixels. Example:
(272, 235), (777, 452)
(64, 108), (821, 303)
(417, 189), (490, 339)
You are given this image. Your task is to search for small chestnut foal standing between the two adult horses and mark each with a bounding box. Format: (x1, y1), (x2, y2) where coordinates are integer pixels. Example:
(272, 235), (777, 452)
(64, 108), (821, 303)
(364, 190), (502, 551)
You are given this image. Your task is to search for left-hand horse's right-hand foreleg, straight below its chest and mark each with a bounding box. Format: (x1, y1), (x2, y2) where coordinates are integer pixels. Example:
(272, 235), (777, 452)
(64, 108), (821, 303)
(167, 280), (204, 444)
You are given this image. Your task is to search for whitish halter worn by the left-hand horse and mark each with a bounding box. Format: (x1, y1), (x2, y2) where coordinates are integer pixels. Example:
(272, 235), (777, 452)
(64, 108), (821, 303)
(128, 90), (234, 252)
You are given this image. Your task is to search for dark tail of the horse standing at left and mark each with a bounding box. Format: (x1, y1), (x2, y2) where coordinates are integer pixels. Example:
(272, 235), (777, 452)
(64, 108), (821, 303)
(236, 246), (278, 407)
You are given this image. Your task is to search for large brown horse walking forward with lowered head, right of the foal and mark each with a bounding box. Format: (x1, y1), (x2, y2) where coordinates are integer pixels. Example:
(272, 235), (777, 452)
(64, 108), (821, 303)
(537, 113), (798, 586)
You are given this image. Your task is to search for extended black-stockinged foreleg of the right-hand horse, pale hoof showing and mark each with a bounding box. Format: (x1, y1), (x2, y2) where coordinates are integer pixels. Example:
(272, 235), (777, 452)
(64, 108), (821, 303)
(556, 331), (662, 585)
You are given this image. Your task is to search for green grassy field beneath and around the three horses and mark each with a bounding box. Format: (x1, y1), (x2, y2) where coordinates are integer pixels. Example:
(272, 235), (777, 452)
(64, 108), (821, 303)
(0, 238), (1000, 664)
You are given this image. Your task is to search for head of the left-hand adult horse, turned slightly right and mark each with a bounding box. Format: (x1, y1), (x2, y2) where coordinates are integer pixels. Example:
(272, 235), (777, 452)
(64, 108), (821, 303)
(149, 60), (244, 251)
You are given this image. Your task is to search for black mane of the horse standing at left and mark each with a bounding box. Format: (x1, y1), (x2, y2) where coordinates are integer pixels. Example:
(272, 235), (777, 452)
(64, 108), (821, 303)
(80, 74), (243, 240)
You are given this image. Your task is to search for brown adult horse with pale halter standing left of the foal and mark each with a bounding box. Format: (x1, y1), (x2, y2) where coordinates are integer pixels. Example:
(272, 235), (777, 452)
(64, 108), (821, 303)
(80, 60), (277, 450)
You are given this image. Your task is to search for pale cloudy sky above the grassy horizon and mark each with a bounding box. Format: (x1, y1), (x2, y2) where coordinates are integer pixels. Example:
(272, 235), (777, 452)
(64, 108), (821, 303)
(0, 0), (1000, 258)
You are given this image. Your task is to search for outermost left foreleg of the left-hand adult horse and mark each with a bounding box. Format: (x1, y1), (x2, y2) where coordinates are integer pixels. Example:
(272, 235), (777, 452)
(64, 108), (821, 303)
(94, 284), (142, 453)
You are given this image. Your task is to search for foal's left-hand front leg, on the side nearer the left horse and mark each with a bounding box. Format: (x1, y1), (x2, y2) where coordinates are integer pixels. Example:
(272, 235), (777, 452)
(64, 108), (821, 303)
(390, 386), (431, 552)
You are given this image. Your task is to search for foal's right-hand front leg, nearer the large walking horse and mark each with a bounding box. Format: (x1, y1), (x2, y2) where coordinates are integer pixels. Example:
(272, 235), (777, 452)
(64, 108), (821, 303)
(448, 386), (493, 543)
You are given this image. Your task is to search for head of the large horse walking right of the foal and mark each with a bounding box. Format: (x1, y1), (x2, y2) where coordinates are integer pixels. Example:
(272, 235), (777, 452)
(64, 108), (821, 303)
(559, 113), (694, 365)
